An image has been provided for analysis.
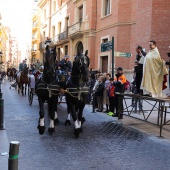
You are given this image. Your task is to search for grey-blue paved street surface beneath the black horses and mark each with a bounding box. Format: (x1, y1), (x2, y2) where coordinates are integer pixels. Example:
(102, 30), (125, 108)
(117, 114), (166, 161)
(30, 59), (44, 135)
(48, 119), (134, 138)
(0, 81), (170, 170)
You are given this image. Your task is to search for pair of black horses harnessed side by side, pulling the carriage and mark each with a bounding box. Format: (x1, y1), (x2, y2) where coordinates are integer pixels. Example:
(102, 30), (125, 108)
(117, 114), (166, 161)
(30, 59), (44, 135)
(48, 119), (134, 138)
(28, 46), (89, 137)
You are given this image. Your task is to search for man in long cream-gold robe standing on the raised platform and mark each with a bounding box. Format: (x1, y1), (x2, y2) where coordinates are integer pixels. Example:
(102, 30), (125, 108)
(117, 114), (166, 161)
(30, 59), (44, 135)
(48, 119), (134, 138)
(141, 41), (168, 97)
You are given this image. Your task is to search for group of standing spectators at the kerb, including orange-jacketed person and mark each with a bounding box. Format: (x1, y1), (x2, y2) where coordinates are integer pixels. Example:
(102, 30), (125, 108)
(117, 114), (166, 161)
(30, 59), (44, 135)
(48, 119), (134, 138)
(89, 67), (126, 118)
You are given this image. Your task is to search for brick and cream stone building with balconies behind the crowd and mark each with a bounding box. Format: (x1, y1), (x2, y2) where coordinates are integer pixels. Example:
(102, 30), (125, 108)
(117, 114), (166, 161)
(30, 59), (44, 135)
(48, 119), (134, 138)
(39, 0), (170, 73)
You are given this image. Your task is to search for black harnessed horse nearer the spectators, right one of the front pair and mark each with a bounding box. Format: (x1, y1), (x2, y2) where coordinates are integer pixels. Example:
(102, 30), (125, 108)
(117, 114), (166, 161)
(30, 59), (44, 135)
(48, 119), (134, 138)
(66, 52), (89, 137)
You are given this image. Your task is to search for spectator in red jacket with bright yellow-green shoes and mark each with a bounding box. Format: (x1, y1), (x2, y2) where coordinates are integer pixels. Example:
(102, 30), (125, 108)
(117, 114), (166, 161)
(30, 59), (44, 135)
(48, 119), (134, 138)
(107, 78), (115, 116)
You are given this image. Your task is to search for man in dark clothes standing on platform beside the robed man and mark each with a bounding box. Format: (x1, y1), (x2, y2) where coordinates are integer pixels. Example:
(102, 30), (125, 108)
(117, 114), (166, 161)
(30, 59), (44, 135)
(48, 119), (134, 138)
(134, 46), (146, 94)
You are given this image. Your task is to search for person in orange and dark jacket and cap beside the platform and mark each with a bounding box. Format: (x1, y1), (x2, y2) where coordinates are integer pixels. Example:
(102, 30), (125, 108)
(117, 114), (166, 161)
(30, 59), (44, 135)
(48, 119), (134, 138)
(112, 67), (126, 119)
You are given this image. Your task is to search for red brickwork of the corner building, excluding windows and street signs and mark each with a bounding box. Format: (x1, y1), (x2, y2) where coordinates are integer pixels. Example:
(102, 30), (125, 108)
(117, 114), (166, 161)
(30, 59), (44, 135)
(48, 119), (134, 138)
(65, 0), (170, 70)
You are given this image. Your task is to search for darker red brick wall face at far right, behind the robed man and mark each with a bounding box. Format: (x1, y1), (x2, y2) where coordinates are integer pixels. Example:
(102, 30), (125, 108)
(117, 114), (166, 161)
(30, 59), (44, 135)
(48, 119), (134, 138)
(151, 0), (170, 60)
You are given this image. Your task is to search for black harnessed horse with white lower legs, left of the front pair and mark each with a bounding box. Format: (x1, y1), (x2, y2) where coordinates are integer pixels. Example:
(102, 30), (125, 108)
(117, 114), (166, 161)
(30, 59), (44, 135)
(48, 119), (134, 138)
(36, 48), (60, 135)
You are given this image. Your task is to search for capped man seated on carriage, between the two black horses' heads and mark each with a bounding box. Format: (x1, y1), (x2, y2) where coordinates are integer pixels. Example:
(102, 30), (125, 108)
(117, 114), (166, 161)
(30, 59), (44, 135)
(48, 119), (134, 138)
(59, 55), (72, 74)
